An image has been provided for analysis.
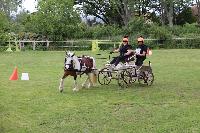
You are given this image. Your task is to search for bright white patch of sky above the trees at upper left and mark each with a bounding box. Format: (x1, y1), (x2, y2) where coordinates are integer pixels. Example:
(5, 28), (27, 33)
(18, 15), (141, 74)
(22, 0), (37, 13)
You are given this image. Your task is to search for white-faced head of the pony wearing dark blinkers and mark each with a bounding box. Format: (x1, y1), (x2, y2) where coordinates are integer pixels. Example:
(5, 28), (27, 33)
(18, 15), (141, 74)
(65, 51), (75, 69)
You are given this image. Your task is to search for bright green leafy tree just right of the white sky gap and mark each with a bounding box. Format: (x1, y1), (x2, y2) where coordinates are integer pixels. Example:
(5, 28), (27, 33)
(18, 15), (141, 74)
(26, 0), (80, 40)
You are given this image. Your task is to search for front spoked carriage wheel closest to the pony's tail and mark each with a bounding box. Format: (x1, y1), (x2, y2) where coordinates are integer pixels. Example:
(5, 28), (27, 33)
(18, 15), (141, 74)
(98, 68), (112, 85)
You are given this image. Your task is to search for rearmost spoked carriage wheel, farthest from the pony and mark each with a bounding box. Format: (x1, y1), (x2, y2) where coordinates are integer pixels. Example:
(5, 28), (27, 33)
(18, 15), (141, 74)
(138, 71), (154, 86)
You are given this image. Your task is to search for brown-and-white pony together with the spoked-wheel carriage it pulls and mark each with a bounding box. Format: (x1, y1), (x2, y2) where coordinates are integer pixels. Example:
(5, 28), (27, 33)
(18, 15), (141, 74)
(59, 52), (154, 92)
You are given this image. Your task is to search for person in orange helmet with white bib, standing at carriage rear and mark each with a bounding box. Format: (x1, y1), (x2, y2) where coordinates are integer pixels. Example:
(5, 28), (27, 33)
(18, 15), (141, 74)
(135, 37), (147, 66)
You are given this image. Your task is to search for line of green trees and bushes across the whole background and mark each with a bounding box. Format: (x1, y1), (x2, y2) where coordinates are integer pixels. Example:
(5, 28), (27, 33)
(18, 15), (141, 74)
(0, 0), (200, 44)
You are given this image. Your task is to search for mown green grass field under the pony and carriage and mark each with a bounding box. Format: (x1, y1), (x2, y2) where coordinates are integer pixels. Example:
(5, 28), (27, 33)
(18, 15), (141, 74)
(0, 49), (200, 133)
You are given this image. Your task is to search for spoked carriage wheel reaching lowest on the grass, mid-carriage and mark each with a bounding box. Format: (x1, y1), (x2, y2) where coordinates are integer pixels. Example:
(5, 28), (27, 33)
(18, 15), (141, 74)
(118, 70), (131, 88)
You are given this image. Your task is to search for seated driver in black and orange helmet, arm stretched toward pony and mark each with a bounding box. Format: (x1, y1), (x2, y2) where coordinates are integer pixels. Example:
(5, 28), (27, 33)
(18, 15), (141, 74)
(110, 38), (133, 66)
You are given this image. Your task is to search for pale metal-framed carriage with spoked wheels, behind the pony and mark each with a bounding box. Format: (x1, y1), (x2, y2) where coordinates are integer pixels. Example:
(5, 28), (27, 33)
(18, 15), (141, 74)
(98, 55), (154, 88)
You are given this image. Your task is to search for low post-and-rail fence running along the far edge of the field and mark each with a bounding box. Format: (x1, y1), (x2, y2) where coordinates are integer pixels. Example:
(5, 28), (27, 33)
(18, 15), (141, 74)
(0, 38), (200, 51)
